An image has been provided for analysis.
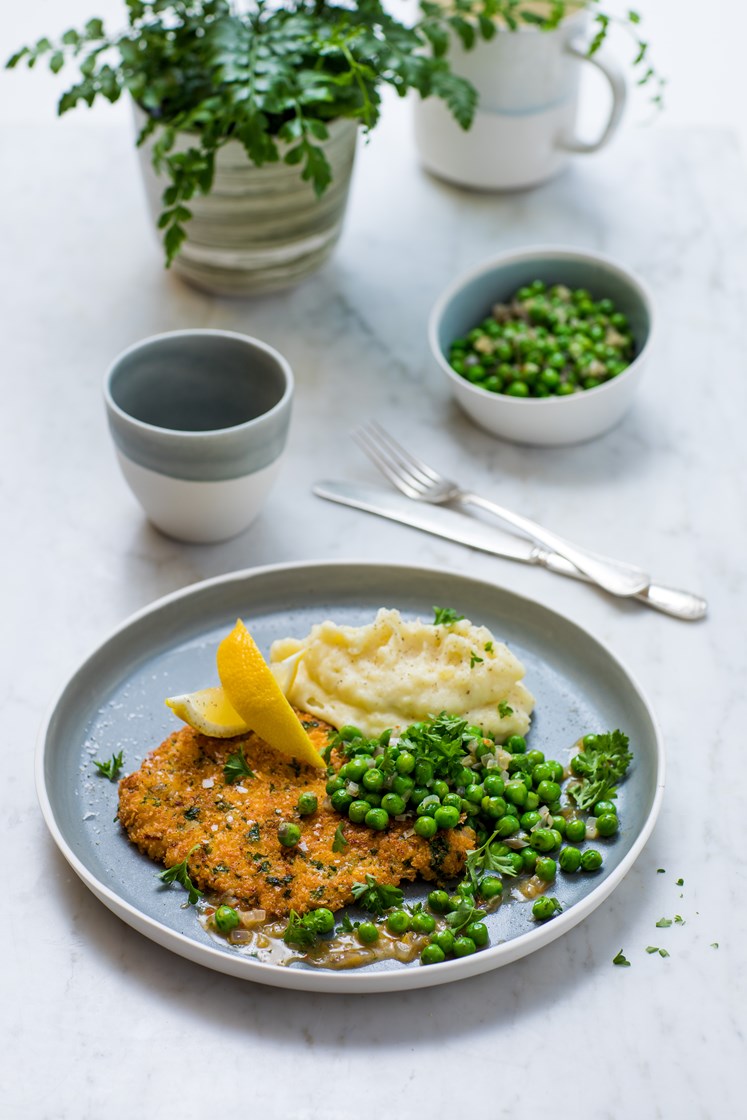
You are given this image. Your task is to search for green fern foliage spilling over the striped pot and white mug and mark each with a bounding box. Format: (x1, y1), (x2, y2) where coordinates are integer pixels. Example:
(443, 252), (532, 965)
(7, 0), (653, 265)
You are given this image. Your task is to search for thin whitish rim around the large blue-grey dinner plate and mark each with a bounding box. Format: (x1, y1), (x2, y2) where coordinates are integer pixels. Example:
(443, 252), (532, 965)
(35, 559), (665, 995)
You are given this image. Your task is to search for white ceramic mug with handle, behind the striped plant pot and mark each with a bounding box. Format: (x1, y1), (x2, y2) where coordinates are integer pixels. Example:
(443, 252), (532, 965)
(414, 10), (626, 190)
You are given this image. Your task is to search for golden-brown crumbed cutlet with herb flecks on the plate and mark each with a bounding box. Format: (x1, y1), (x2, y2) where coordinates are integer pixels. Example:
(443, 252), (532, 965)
(119, 712), (475, 917)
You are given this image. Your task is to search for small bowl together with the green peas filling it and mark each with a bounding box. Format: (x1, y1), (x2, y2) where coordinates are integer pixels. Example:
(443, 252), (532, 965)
(428, 248), (653, 446)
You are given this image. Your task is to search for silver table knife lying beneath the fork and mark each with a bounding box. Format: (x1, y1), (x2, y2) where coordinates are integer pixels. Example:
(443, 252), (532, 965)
(314, 482), (708, 622)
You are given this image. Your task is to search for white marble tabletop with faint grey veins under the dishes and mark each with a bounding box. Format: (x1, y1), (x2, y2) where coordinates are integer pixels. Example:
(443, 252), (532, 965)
(0, 98), (747, 1120)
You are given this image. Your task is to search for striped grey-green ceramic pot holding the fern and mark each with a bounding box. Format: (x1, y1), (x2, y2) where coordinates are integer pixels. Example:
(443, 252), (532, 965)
(136, 110), (357, 296)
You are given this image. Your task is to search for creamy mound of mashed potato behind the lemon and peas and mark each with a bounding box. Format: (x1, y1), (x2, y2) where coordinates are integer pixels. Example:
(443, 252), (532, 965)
(270, 609), (534, 743)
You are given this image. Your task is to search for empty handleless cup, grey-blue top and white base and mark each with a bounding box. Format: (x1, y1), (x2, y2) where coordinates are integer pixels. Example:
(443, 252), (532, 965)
(104, 329), (293, 543)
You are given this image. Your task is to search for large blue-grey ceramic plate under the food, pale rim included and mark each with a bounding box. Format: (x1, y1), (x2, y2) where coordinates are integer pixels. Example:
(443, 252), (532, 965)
(37, 562), (664, 992)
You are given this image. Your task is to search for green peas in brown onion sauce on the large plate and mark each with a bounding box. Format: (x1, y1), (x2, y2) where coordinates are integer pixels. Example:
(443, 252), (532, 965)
(199, 713), (633, 969)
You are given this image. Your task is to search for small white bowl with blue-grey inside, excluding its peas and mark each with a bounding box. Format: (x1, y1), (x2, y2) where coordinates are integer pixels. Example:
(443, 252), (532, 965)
(428, 245), (654, 447)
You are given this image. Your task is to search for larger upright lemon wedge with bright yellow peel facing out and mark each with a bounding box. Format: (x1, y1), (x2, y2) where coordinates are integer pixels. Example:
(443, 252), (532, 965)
(212, 619), (325, 768)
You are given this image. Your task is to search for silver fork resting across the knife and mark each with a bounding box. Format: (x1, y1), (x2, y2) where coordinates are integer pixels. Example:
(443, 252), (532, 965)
(352, 421), (651, 598)
